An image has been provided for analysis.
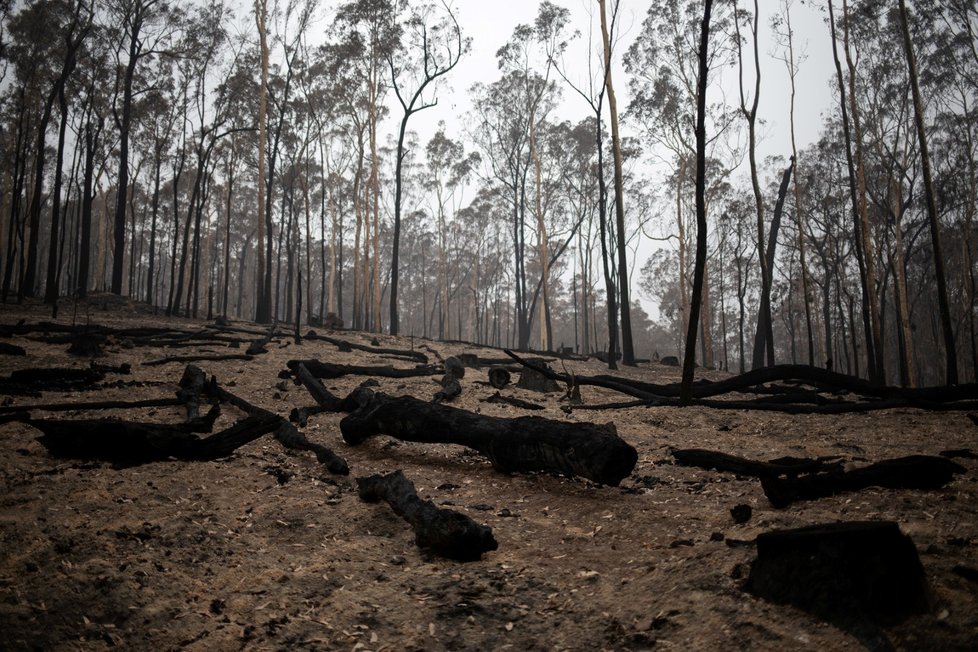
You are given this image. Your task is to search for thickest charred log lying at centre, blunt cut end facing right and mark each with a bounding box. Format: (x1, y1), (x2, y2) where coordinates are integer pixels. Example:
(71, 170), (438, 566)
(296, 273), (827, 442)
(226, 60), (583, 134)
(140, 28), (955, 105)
(340, 390), (638, 486)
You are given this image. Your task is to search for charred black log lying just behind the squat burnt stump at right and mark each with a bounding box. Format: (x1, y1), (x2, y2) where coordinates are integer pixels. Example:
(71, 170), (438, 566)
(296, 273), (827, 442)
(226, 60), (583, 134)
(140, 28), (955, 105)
(761, 455), (967, 507)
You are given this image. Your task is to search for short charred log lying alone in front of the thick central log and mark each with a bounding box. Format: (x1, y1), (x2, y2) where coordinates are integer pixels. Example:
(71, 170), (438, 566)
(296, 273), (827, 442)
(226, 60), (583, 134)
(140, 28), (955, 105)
(357, 471), (499, 561)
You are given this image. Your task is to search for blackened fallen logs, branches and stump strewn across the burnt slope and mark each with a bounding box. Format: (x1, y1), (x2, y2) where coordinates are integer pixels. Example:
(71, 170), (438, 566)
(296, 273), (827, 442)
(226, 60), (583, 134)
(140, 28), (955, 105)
(0, 320), (978, 600)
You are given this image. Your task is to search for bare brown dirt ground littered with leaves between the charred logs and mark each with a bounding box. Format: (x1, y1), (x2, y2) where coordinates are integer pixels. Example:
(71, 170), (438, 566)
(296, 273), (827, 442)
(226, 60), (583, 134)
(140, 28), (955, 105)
(0, 300), (978, 651)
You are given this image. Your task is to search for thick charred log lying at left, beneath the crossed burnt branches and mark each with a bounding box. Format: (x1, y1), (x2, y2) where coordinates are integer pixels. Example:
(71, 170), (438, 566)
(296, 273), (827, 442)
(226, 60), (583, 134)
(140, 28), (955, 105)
(27, 407), (280, 465)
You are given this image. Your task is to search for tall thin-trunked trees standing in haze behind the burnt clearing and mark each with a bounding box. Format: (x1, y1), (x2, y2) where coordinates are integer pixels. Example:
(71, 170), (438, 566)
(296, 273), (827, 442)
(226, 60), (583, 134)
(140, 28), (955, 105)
(0, 0), (978, 385)
